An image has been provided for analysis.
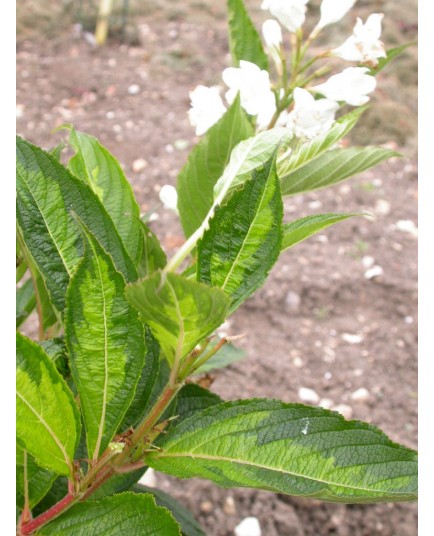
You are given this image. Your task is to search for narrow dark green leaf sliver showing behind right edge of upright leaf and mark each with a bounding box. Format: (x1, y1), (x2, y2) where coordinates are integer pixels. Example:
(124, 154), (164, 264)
(120, 326), (160, 431)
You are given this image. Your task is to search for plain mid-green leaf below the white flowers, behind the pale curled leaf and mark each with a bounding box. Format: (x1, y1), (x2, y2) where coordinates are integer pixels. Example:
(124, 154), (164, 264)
(177, 97), (253, 237)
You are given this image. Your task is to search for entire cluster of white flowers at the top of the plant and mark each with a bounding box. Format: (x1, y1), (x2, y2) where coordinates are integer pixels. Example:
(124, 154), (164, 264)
(188, 0), (386, 140)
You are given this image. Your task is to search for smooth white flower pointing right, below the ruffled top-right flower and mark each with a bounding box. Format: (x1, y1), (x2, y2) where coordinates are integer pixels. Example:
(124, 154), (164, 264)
(311, 67), (377, 106)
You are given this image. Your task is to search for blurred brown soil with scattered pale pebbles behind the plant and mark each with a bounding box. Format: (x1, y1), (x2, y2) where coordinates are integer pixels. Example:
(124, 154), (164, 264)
(17, 0), (417, 536)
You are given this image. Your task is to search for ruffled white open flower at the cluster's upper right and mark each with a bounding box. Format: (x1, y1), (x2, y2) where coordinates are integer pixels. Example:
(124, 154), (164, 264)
(332, 13), (386, 67)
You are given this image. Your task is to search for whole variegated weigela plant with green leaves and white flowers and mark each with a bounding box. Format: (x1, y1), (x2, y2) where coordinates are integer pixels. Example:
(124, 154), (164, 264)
(17, 0), (417, 536)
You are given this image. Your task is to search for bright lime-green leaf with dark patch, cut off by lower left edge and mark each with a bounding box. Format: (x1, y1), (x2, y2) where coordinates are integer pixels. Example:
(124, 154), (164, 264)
(17, 333), (80, 475)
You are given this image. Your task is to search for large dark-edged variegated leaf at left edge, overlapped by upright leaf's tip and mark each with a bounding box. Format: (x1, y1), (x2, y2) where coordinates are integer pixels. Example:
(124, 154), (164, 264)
(17, 138), (137, 311)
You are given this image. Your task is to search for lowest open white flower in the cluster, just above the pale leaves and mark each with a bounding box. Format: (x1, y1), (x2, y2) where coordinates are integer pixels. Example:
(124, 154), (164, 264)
(286, 87), (339, 139)
